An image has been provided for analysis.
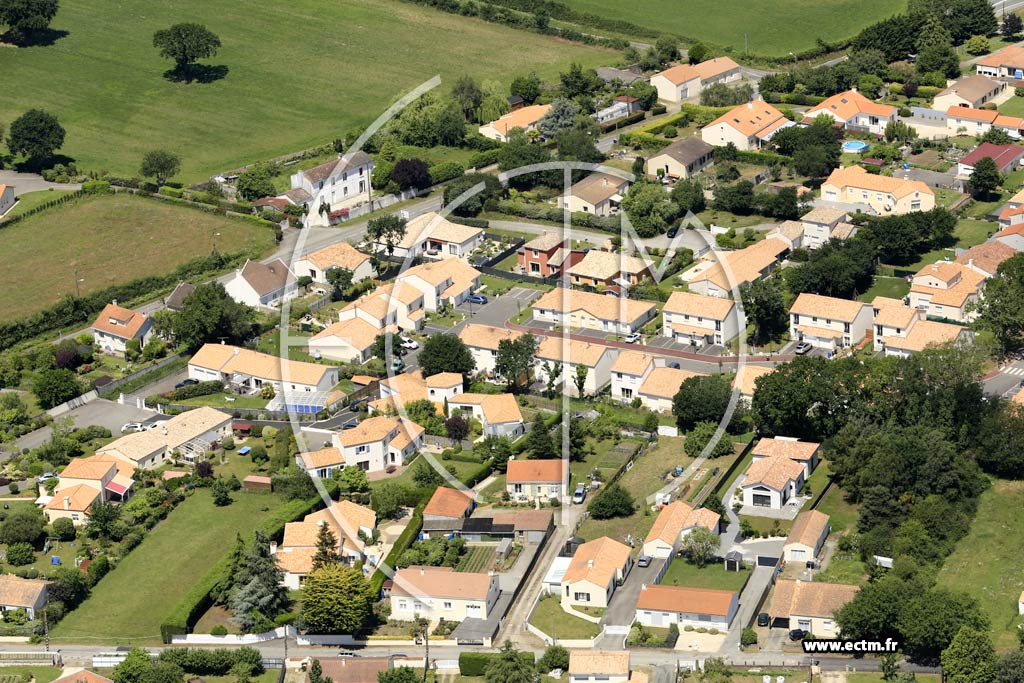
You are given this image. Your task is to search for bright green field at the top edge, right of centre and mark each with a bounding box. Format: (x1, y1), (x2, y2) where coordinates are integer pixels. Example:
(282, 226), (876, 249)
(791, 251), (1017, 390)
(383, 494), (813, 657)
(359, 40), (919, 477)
(552, 0), (906, 56)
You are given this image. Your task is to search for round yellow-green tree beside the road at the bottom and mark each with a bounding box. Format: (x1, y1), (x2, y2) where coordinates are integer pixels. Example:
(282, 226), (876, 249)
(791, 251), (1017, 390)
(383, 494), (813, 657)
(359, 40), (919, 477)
(302, 564), (372, 634)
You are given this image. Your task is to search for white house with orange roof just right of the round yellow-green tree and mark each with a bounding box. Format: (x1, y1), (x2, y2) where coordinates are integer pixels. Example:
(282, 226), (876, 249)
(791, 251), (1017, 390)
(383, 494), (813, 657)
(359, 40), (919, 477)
(391, 566), (501, 624)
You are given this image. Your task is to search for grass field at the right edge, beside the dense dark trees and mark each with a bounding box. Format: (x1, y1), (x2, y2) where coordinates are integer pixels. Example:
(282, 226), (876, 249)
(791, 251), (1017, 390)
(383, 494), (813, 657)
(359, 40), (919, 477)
(939, 480), (1024, 650)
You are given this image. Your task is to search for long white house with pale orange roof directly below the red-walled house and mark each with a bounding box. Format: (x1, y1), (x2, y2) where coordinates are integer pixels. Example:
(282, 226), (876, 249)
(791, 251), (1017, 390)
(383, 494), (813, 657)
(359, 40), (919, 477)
(530, 286), (657, 335)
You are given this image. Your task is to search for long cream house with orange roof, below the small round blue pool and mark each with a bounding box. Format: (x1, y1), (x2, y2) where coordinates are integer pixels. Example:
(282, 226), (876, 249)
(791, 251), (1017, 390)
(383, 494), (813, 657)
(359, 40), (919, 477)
(821, 166), (935, 216)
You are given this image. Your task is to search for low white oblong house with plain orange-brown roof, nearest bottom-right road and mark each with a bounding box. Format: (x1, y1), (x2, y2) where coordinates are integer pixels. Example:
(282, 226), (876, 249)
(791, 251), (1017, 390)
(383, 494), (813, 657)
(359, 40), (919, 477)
(636, 586), (739, 632)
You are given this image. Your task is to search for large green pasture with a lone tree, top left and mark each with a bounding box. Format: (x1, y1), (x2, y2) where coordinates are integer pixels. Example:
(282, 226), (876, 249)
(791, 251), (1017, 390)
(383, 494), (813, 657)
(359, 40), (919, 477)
(0, 0), (616, 182)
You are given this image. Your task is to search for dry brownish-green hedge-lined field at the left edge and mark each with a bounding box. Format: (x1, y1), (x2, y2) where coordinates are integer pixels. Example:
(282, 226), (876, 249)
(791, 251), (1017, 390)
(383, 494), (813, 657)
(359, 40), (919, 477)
(0, 195), (273, 319)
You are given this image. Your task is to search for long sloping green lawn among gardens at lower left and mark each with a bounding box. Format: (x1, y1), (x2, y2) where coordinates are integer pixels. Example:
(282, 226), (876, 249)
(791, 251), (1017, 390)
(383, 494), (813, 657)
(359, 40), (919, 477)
(50, 489), (283, 643)
